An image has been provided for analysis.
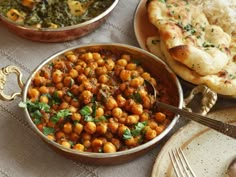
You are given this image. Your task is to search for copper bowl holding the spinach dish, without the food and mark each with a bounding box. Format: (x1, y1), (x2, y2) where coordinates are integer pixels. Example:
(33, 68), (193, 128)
(0, 0), (119, 42)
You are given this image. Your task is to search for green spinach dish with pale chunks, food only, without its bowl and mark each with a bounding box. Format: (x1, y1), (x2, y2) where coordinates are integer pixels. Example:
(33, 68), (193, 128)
(0, 0), (114, 28)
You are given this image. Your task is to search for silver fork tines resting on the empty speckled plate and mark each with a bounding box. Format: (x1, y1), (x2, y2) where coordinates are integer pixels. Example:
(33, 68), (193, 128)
(169, 148), (196, 177)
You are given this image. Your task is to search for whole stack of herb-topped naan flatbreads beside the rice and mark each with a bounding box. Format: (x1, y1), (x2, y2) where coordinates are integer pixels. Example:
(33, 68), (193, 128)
(146, 0), (236, 96)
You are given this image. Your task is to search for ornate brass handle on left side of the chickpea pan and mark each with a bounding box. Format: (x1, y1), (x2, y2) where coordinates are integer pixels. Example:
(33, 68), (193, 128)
(0, 65), (24, 101)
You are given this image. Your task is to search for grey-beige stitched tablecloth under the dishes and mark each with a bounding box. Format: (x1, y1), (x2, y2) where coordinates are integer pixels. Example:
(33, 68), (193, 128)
(0, 0), (235, 177)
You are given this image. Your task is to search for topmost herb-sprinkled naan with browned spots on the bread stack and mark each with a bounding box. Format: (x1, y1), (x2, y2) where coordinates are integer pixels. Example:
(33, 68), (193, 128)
(147, 0), (231, 75)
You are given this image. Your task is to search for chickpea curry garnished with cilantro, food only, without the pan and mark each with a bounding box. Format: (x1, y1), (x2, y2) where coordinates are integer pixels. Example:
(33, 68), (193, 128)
(20, 49), (173, 153)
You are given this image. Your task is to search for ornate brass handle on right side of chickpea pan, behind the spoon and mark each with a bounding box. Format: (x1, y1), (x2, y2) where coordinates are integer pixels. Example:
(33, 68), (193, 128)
(184, 85), (217, 115)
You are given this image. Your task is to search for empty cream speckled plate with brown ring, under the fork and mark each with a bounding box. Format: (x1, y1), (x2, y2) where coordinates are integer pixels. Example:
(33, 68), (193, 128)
(152, 107), (236, 177)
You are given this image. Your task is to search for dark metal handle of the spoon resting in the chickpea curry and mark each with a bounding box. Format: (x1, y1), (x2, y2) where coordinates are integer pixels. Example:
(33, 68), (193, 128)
(156, 102), (236, 139)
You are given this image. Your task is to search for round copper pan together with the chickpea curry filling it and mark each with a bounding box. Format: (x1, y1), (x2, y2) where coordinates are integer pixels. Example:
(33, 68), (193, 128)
(0, 44), (183, 165)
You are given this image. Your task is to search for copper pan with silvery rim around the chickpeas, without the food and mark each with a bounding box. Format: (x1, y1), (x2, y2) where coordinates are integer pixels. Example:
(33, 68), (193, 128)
(0, 43), (216, 165)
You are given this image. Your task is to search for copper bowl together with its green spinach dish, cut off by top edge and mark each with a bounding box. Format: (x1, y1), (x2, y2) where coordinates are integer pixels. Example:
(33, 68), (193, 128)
(0, 0), (119, 42)
